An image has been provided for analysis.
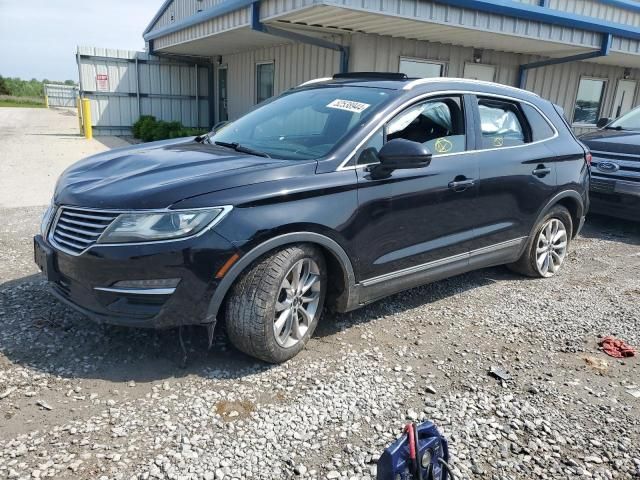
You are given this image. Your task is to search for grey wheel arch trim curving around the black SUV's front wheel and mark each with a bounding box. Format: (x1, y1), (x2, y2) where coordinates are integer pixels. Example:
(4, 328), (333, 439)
(205, 232), (356, 323)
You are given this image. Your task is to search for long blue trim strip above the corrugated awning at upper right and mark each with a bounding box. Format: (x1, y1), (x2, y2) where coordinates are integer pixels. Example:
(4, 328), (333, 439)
(437, 0), (640, 40)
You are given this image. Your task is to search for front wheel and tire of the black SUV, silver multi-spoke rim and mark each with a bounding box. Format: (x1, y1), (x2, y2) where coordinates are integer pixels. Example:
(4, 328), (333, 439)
(225, 244), (327, 363)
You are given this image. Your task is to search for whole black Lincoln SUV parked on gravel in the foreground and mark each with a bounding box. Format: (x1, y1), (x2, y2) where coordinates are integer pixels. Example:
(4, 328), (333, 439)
(35, 74), (589, 362)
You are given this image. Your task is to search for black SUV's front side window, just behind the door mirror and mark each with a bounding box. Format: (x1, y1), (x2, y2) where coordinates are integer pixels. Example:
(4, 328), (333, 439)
(387, 97), (467, 157)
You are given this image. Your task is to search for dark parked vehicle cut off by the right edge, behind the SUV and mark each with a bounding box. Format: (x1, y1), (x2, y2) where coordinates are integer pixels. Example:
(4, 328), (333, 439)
(580, 107), (640, 221)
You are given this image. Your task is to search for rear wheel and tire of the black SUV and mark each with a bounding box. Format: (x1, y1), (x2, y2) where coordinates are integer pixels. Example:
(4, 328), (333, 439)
(507, 205), (573, 278)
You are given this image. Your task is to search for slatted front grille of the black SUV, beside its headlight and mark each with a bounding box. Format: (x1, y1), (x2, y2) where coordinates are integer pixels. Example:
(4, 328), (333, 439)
(49, 207), (120, 255)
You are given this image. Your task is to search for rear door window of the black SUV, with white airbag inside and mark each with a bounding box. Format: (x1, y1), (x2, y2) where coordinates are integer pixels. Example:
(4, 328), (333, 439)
(478, 98), (529, 149)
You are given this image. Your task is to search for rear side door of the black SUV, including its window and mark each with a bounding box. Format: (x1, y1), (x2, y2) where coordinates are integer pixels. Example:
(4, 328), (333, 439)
(474, 95), (557, 249)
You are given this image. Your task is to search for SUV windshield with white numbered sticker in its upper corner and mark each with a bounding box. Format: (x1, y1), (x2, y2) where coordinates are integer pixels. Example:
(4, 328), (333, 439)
(210, 86), (393, 160)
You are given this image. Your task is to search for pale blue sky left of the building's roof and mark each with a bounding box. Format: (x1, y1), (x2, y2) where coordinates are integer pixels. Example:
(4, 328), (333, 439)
(0, 0), (163, 82)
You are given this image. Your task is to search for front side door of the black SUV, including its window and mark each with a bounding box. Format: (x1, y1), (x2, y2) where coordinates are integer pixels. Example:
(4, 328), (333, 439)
(354, 96), (478, 280)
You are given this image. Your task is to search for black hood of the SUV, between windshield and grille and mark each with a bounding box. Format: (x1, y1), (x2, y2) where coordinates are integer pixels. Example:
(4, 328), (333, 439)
(54, 138), (300, 209)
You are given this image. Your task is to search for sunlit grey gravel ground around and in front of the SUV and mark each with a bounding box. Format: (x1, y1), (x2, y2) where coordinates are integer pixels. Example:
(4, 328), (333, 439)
(0, 207), (640, 479)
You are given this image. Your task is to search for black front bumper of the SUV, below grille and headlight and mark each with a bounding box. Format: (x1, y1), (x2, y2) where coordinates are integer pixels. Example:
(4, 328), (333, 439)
(34, 231), (237, 328)
